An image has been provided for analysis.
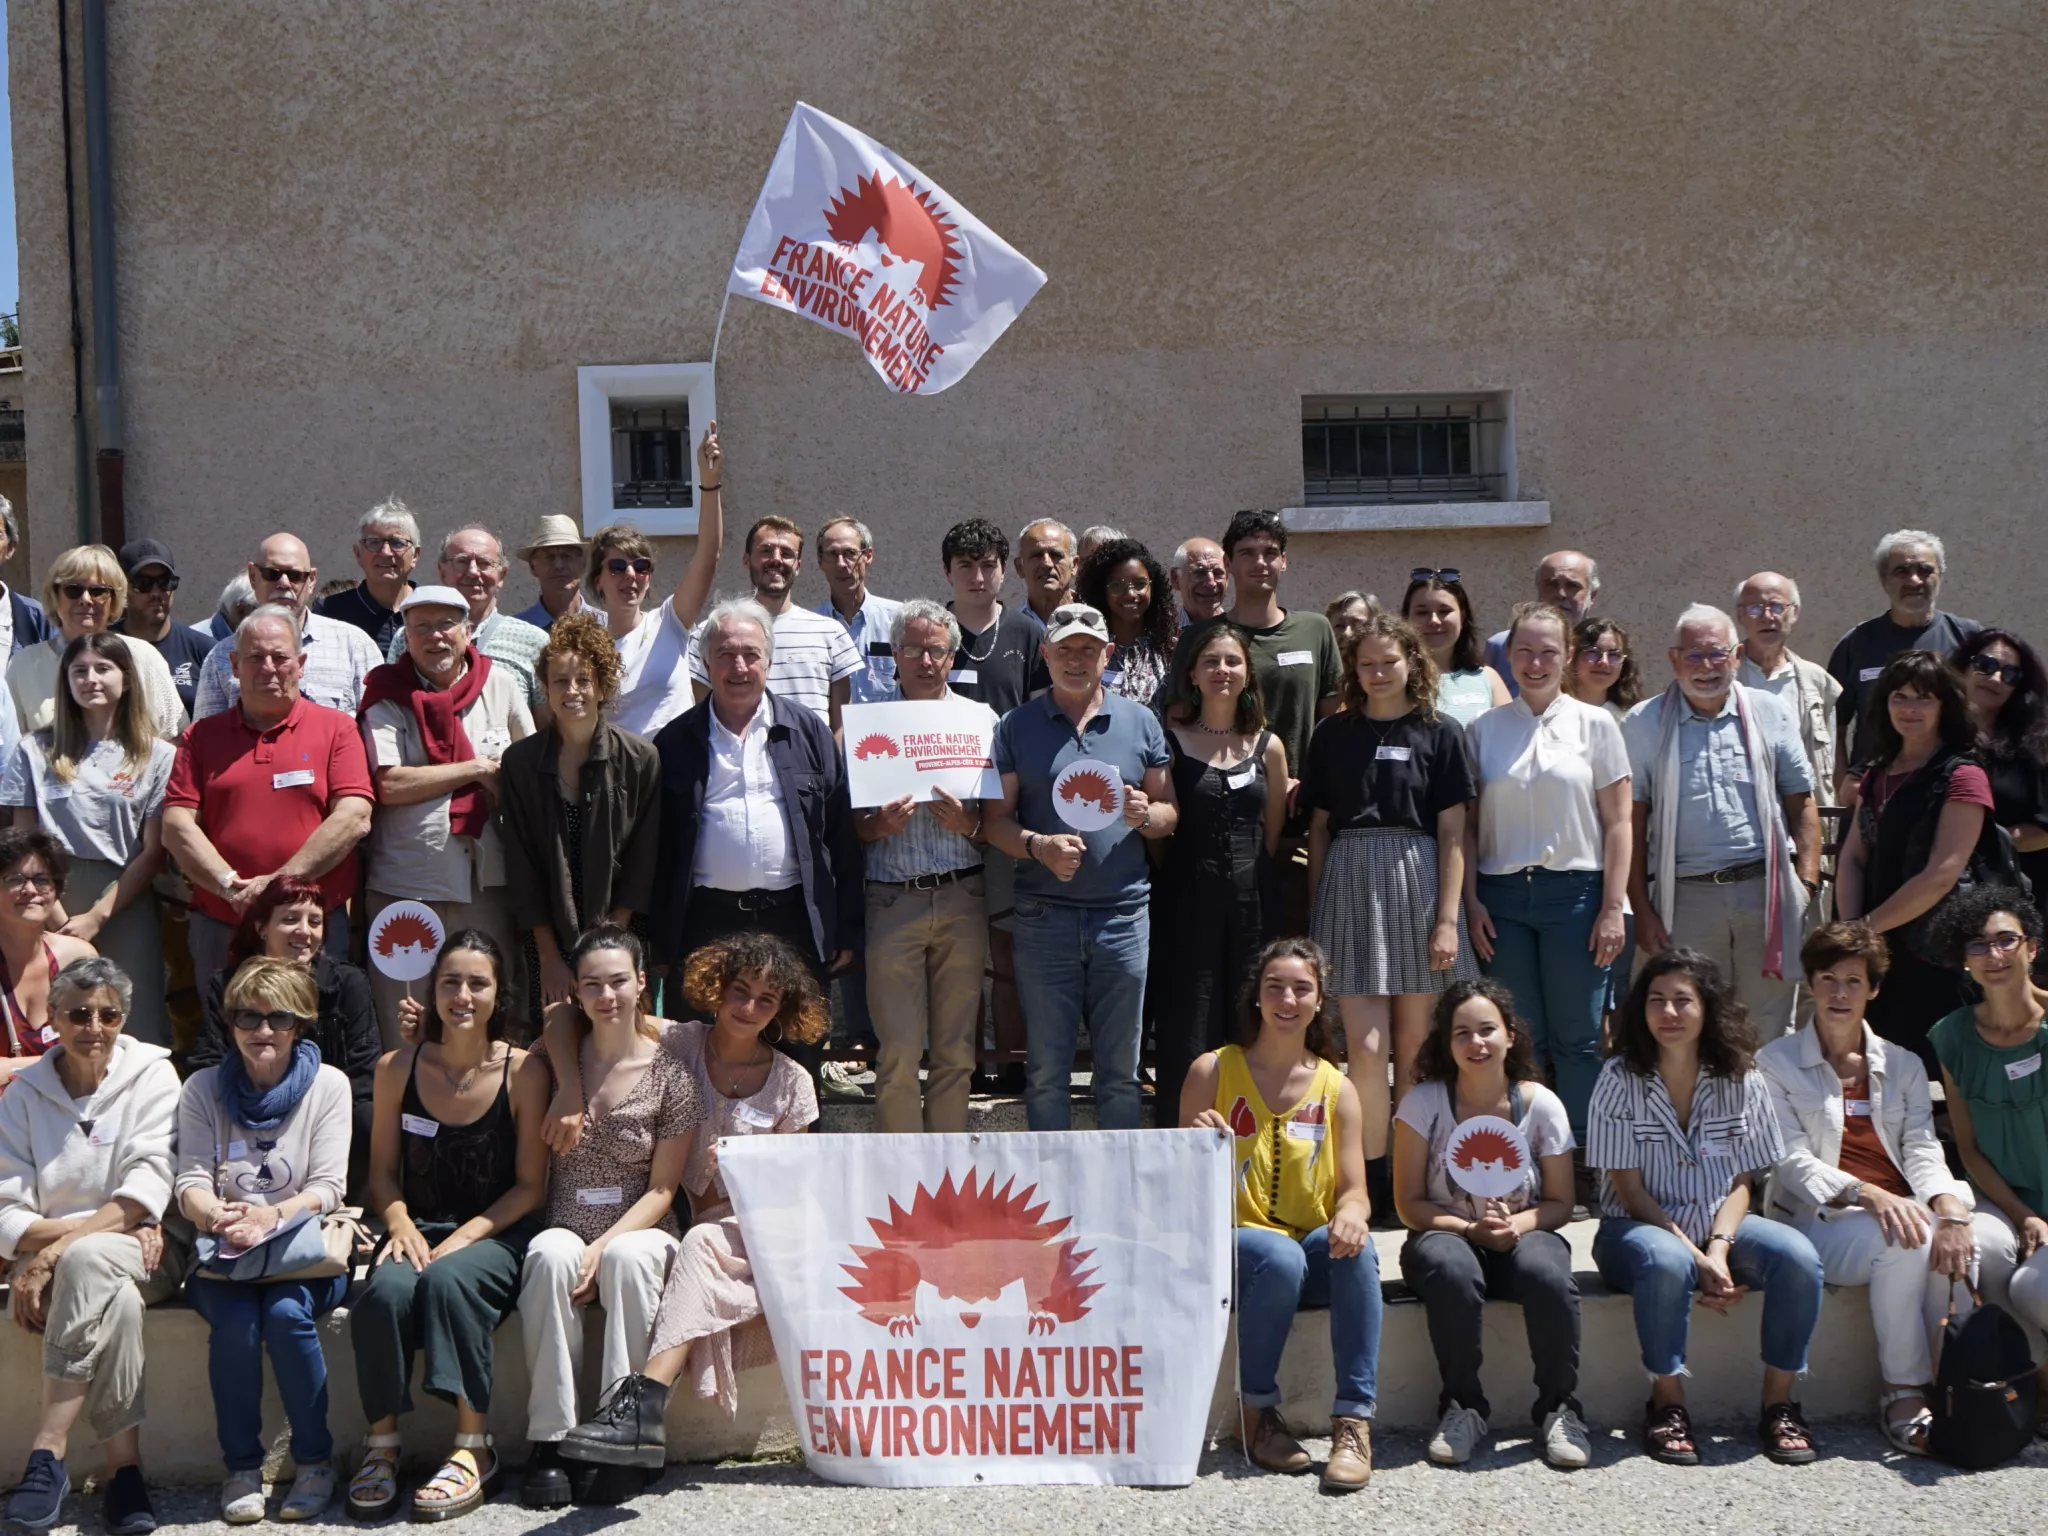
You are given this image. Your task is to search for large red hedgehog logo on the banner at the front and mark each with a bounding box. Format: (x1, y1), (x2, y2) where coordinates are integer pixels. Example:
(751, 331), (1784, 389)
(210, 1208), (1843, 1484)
(840, 1174), (1102, 1337)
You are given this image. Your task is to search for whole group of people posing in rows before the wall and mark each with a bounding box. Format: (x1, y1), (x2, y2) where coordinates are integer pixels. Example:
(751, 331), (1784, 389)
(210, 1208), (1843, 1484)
(0, 426), (2048, 1536)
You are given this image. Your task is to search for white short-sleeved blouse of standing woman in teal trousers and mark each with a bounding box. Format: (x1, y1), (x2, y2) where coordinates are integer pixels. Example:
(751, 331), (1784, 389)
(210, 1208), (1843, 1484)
(1464, 694), (1628, 874)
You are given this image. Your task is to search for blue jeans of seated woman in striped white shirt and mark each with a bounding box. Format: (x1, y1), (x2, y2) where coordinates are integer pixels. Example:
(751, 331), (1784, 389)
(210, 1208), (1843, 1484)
(1593, 1217), (1821, 1376)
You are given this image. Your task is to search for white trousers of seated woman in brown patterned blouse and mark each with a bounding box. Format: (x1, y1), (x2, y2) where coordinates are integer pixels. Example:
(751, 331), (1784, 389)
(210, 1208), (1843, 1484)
(518, 1227), (676, 1442)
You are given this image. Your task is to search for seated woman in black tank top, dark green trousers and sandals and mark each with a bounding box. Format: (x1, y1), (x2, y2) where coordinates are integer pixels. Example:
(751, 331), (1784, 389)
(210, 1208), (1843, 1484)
(348, 928), (547, 1520)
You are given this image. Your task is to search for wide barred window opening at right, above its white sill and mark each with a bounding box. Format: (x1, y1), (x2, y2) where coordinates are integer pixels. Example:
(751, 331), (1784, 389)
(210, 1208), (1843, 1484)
(1300, 395), (1507, 506)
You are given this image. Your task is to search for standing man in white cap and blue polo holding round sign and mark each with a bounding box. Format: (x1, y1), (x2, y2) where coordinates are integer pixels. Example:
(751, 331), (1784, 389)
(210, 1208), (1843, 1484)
(985, 602), (1180, 1130)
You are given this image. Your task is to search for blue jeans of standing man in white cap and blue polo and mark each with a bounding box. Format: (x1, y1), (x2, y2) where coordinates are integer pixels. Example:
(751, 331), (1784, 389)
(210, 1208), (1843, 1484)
(1016, 895), (1151, 1130)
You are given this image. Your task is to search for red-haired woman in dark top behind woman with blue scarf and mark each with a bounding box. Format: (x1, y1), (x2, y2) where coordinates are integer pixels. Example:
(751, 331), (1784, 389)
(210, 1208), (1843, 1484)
(184, 874), (383, 1202)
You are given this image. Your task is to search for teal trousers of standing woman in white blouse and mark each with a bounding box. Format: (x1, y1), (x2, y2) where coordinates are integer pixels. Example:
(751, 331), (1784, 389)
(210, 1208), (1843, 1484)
(1479, 868), (1608, 1147)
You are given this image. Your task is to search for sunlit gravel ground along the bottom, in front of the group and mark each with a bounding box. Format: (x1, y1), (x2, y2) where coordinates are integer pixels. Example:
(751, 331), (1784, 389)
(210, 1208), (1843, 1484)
(36, 1423), (2048, 1536)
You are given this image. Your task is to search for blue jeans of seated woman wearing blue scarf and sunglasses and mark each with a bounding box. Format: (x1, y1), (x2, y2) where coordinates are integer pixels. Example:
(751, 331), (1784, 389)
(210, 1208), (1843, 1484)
(186, 1274), (348, 1473)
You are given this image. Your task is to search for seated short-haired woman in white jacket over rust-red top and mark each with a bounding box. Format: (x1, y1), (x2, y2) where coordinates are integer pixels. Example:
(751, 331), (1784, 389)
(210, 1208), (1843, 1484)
(1757, 922), (1997, 1456)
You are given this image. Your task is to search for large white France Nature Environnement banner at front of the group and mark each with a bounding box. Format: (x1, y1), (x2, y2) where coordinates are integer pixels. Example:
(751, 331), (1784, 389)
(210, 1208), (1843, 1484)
(719, 1130), (1233, 1487)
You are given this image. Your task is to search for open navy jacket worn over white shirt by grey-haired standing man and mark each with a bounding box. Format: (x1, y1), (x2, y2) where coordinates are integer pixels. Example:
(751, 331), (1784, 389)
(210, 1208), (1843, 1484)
(653, 692), (866, 965)
